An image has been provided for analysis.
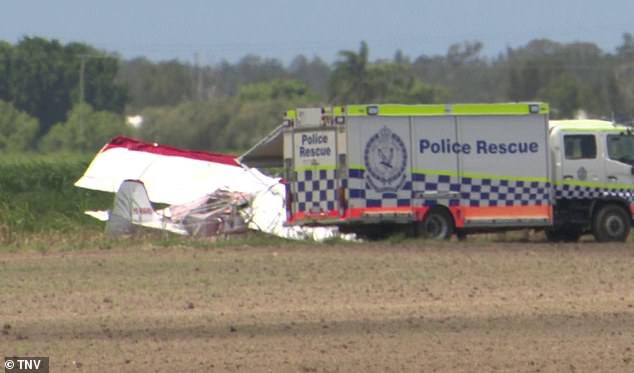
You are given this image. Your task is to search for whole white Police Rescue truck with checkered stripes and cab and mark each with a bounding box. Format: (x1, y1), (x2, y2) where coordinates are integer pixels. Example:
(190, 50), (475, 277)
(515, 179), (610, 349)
(266, 103), (634, 241)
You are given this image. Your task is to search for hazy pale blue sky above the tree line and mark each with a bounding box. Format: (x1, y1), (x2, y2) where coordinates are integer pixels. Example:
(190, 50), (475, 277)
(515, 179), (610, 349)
(0, 0), (634, 64)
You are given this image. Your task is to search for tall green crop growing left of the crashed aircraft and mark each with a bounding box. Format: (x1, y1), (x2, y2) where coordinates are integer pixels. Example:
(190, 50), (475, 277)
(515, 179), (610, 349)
(0, 156), (112, 243)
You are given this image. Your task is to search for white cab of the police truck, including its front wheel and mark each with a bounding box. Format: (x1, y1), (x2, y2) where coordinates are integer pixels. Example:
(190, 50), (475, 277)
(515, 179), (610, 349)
(546, 120), (634, 241)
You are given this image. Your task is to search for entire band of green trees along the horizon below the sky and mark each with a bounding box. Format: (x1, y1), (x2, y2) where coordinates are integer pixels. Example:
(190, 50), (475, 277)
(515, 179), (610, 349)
(0, 33), (634, 152)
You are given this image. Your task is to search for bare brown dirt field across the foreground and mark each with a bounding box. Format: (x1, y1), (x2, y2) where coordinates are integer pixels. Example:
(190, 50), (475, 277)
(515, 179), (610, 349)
(0, 242), (634, 372)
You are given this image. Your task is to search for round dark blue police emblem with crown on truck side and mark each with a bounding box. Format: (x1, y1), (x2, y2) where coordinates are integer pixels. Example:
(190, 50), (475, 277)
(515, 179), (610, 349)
(364, 127), (407, 193)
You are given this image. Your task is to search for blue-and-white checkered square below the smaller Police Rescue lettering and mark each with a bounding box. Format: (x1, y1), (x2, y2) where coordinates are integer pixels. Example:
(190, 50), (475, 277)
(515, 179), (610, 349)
(296, 170), (336, 212)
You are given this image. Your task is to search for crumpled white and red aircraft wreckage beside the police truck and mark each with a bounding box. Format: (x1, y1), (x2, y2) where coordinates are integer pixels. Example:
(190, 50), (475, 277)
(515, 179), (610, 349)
(75, 137), (351, 240)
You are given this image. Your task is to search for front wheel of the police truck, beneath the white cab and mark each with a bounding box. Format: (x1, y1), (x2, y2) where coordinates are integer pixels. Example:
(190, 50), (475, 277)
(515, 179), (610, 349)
(592, 205), (632, 242)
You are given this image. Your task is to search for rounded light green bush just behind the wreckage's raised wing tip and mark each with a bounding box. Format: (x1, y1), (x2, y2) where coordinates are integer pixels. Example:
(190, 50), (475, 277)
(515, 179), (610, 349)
(39, 104), (134, 153)
